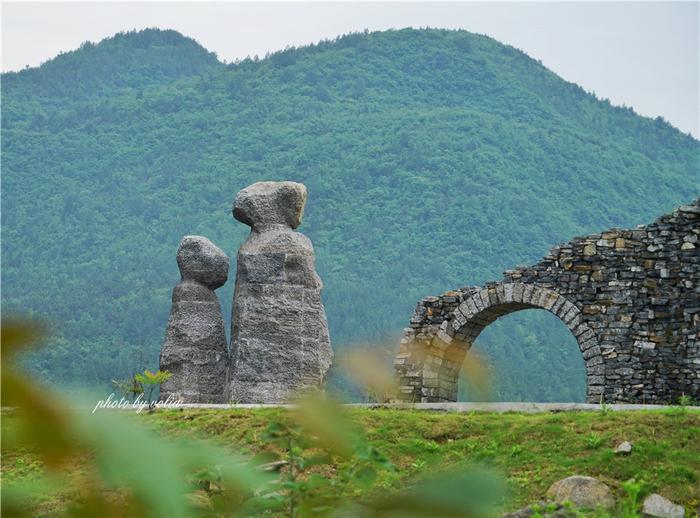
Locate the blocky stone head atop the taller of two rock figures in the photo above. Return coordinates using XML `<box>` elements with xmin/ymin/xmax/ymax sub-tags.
<box><xmin>233</xmin><ymin>182</ymin><xmax>306</xmax><ymax>230</ymax></box>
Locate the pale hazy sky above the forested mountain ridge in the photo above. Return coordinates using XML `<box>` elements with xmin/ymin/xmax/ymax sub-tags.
<box><xmin>2</xmin><ymin>1</ymin><xmax>700</xmax><ymax>137</ymax></box>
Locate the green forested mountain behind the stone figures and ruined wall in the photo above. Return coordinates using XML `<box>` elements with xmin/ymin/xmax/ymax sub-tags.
<box><xmin>2</xmin><ymin>30</ymin><xmax>700</xmax><ymax>400</ymax></box>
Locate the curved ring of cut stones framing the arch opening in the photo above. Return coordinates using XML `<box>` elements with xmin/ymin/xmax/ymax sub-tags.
<box><xmin>432</xmin><ymin>282</ymin><xmax>604</xmax><ymax>402</ymax></box>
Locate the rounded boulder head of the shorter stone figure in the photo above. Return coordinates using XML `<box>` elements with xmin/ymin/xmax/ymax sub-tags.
<box><xmin>177</xmin><ymin>236</ymin><xmax>228</xmax><ymax>290</ymax></box>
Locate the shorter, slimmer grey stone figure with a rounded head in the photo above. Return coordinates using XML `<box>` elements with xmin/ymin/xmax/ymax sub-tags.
<box><xmin>160</xmin><ymin>236</ymin><xmax>229</xmax><ymax>403</ymax></box>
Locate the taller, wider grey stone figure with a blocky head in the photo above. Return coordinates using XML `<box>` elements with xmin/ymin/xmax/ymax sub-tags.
<box><xmin>230</xmin><ymin>182</ymin><xmax>333</xmax><ymax>403</ymax></box>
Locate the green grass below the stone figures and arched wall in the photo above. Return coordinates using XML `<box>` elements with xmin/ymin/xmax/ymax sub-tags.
<box><xmin>2</xmin><ymin>408</ymin><xmax>700</xmax><ymax>516</ymax></box>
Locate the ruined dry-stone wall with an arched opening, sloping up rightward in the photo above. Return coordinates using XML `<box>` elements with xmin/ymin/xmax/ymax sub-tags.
<box><xmin>394</xmin><ymin>200</ymin><xmax>700</xmax><ymax>403</ymax></box>
